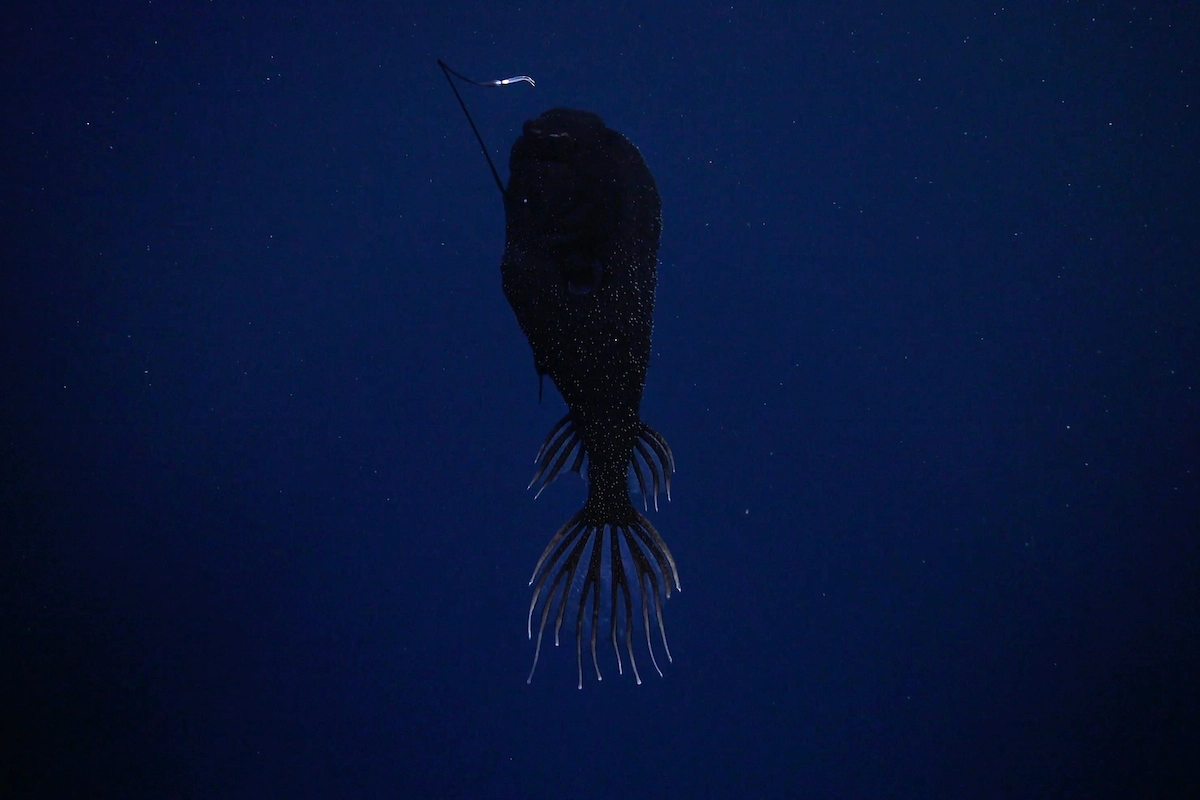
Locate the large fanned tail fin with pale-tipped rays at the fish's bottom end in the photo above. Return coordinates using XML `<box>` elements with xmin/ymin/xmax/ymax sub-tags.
<box><xmin>526</xmin><ymin>505</ymin><xmax>679</xmax><ymax>688</ymax></box>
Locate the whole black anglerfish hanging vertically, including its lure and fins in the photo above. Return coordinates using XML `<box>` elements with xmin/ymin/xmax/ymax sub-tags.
<box><xmin>438</xmin><ymin>61</ymin><xmax>679</xmax><ymax>688</ymax></box>
